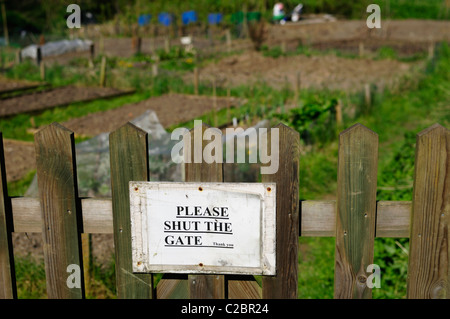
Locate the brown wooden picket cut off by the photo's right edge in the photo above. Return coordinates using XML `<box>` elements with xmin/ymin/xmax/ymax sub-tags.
<box><xmin>407</xmin><ymin>124</ymin><xmax>450</xmax><ymax>299</ymax></box>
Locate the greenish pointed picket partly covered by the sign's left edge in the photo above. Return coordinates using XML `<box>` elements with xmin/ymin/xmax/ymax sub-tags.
<box><xmin>109</xmin><ymin>123</ymin><xmax>153</xmax><ymax>299</ymax></box>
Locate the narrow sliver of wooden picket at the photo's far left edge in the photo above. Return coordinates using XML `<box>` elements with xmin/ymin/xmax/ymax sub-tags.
<box><xmin>0</xmin><ymin>133</ymin><xmax>17</xmax><ymax>299</ymax></box>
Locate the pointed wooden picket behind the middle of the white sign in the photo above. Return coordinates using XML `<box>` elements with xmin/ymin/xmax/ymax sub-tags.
<box><xmin>185</xmin><ymin>124</ymin><xmax>225</xmax><ymax>299</ymax></box>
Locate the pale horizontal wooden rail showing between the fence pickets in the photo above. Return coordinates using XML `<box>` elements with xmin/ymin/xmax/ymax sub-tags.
<box><xmin>11</xmin><ymin>197</ymin><xmax>411</xmax><ymax>238</ymax></box>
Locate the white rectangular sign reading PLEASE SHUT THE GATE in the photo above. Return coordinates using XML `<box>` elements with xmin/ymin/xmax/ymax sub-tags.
<box><xmin>130</xmin><ymin>182</ymin><xmax>276</xmax><ymax>275</ymax></box>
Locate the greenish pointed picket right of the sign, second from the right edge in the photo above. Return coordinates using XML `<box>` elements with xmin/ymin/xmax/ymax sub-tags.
<box><xmin>334</xmin><ymin>124</ymin><xmax>378</xmax><ymax>299</ymax></box>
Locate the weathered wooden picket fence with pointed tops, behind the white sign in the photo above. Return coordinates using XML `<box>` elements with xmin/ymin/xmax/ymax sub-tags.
<box><xmin>0</xmin><ymin>123</ymin><xmax>450</xmax><ymax>299</ymax></box>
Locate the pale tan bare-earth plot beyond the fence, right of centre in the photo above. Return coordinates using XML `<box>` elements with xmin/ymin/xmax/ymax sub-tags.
<box><xmin>195</xmin><ymin>52</ymin><xmax>417</xmax><ymax>91</ymax></box>
